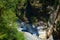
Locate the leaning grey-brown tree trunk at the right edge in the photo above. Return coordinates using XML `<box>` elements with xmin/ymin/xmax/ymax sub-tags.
<box><xmin>48</xmin><ymin>1</ymin><xmax>60</xmax><ymax>38</ymax></box>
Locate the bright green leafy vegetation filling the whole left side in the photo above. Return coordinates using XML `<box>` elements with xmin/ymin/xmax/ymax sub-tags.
<box><xmin>0</xmin><ymin>0</ymin><xmax>25</xmax><ymax>40</ymax></box>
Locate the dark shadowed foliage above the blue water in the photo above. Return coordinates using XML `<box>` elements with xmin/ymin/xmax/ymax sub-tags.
<box><xmin>16</xmin><ymin>0</ymin><xmax>59</xmax><ymax>23</ymax></box>
